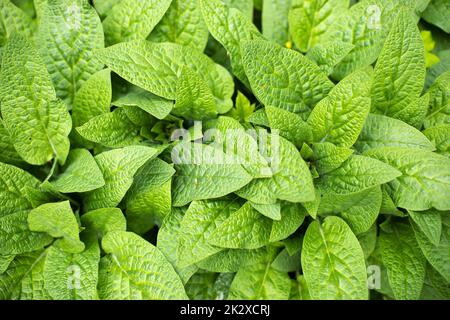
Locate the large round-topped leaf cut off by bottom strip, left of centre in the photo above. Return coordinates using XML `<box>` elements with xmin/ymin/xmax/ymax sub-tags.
<box><xmin>98</xmin><ymin>231</ymin><xmax>187</xmax><ymax>300</ymax></box>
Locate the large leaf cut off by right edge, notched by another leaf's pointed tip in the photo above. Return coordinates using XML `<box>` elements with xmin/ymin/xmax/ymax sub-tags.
<box><xmin>366</xmin><ymin>147</ymin><xmax>450</xmax><ymax>211</ymax></box>
